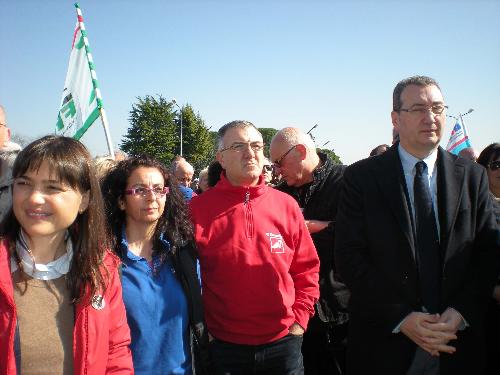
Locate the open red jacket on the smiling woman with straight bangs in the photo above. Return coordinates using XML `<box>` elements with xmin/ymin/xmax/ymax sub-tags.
<box><xmin>0</xmin><ymin>241</ymin><xmax>134</xmax><ymax>375</ymax></box>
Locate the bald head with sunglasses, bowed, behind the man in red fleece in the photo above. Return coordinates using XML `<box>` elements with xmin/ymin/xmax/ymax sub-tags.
<box><xmin>270</xmin><ymin>127</ymin><xmax>320</xmax><ymax>186</ymax></box>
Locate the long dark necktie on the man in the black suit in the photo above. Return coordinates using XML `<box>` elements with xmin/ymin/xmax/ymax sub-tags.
<box><xmin>413</xmin><ymin>161</ymin><xmax>441</xmax><ymax>314</ymax></box>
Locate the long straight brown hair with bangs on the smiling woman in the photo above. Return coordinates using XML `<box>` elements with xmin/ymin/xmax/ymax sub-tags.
<box><xmin>2</xmin><ymin>135</ymin><xmax>109</xmax><ymax>302</ymax></box>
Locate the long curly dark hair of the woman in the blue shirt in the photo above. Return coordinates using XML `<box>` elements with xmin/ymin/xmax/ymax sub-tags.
<box><xmin>102</xmin><ymin>155</ymin><xmax>194</xmax><ymax>261</ymax></box>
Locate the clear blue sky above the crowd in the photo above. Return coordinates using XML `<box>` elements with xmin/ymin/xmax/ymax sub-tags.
<box><xmin>0</xmin><ymin>0</ymin><xmax>500</xmax><ymax>164</ymax></box>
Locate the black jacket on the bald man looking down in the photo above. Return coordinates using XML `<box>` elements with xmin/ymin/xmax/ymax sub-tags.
<box><xmin>276</xmin><ymin>153</ymin><xmax>349</xmax><ymax>324</ymax></box>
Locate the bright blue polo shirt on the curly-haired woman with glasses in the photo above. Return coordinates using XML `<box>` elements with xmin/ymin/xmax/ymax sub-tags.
<box><xmin>121</xmin><ymin>231</ymin><xmax>192</xmax><ymax>375</ymax></box>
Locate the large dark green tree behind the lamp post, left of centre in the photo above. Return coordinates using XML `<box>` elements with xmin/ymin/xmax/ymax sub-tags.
<box><xmin>120</xmin><ymin>95</ymin><xmax>215</xmax><ymax>169</ymax></box>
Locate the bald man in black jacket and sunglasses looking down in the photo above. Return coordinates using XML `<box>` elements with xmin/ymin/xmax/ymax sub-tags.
<box><xmin>270</xmin><ymin>127</ymin><xmax>349</xmax><ymax>375</ymax></box>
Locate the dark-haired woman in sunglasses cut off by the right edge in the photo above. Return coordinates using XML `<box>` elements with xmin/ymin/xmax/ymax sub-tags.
<box><xmin>477</xmin><ymin>143</ymin><xmax>500</xmax><ymax>374</ymax></box>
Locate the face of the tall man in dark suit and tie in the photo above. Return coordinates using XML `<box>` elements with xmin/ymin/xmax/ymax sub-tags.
<box><xmin>391</xmin><ymin>85</ymin><xmax>446</xmax><ymax>158</ymax></box>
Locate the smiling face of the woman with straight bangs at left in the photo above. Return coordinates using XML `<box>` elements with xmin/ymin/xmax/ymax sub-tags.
<box><xmin>12</xmin><ymin>162</ymin><xmax>89</xmax><ymax>245</ymax></box>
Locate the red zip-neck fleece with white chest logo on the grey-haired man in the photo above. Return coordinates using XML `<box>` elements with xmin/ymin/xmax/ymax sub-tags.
<box><xmin>190</xmin><ymin>176</ymin><xmax>319</xmax><ymax>345</ymax></box>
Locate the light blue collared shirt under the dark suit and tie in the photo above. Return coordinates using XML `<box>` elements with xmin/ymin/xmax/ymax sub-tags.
<box><xmin>398</xmin><ymin>143</ymin><xmax>439</xmax><ymax>236</ymax></box>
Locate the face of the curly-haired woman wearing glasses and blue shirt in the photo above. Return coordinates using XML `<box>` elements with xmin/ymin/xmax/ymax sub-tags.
<box><xmin>119</xmin><ymin>167</ymin><xmax>166</xmax><ymax>227</ymax></box>
